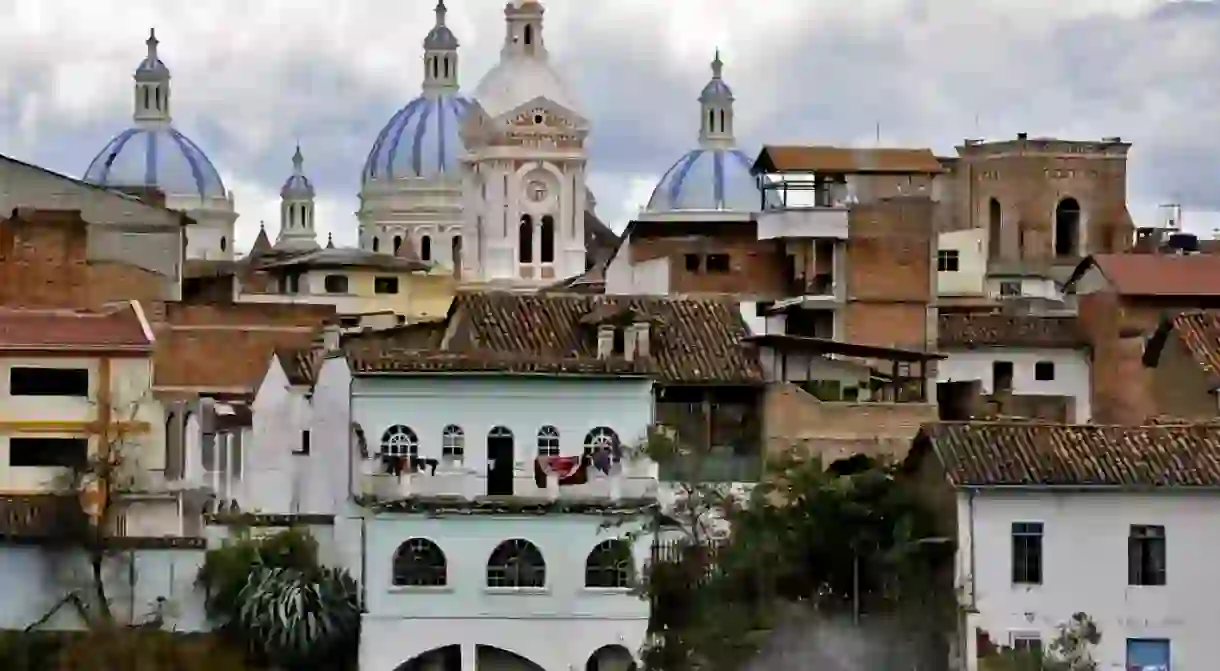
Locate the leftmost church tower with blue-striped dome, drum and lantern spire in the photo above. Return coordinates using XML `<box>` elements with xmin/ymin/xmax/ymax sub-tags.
<box><xmin>83</xmin><ymin>31</ymin><xmax>237</xmax><ymax>259</ymax></box>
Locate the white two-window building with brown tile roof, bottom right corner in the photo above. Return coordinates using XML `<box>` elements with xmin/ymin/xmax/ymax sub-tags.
<box><xmin>913</xmin><ymin>423</ymin><xmax>1220</xmax><ymax>671</ymax></box>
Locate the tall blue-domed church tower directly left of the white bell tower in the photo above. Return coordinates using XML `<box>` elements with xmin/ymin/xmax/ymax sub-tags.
<box><xmin>356</xmin><ymin>0</ymin><xmax>471</xmax><ymax>268</ymax></box>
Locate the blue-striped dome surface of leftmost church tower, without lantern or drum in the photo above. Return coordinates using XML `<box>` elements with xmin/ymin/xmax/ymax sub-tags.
<box><xmin>83</xmin><ymin>126</ymin><xmax>226</xmax><ymax>198</ymax></box>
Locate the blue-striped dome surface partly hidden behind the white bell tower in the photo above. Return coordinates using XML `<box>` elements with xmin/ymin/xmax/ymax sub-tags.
<box><xmin>362</xmin><ymin>93</ymin><xmax>473</xmax><ymax>181</ymax></box>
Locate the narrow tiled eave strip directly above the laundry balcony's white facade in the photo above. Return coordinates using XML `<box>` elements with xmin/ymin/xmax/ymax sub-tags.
<box><xmin>348</xmin><ymin>350</ymin><xmax>649</xmax><ymax>377</ymax></box>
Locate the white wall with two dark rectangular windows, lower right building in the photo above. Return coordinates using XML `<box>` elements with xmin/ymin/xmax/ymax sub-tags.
<box><xmin>958</xmin><ymin>490</ymin><xmax>1220</xmax><ymax>671</ymax></box>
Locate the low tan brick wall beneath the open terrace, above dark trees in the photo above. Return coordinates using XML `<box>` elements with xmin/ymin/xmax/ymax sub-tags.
<box><xmin>763</xmin><ymin>383</ymin><xmax>937</xmax><ymax>464</ymax></box>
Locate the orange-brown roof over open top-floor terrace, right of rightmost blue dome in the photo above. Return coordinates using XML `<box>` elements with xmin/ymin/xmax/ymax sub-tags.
<box><xmin>754</xmin><ymin>145</ymin><xmax>944</xmax><ymax>173</ymax></box>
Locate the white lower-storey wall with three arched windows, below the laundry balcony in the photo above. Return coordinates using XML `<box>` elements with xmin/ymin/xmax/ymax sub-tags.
<box><xmin>360</xmin><ymin>514</ymin><xmax>651</xmax><ymax>671</ymax></box>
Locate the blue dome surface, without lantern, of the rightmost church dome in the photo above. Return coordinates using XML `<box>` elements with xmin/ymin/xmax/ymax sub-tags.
<box><xmin>648</xmin><ymin>149</ymin><xmax>763</xmax><ymax>212</ymax></box>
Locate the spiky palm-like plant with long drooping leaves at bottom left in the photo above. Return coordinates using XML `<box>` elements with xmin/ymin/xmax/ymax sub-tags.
<box><xmin>237</xmin><ymin>565</ymin><xmax>360</xmax><ymax>664</ymax></box>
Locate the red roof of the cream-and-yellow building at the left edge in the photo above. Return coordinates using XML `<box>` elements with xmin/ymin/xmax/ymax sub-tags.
<box><xmin>0</xmin><ymin>303</ymin><xmax>153</xmax><ymax>353</ymax></box>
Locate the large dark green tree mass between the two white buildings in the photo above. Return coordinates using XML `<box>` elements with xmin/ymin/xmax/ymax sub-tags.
<box><xmin>642</xmin><ymin>434</ymin><xmax>956</xmax><ymax>671</ymax></box>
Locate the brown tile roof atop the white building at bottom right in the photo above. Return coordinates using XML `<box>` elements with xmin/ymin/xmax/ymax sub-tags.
<box><xmin>915</xmin><ymin>422</ymin><xmax>1220</xmax><ymax>488</ymax></box>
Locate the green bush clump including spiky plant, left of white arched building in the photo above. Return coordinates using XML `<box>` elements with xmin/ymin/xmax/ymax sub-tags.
<box><xmin>196</xmin><ymin>529</ymin><xmax>360</xmax><ymax>669</ymax></box>
